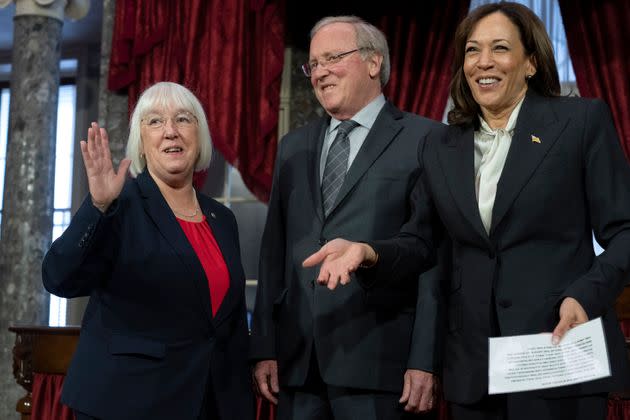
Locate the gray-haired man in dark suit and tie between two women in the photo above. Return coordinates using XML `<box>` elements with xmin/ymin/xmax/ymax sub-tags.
<box><xmin>251</xmin><ymin>16</ymin><xmax>445</xmax><ymax>420</ymax></box>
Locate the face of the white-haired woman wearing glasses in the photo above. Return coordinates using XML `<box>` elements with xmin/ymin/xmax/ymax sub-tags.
<box><xmin>141</xmin><ymin>109</ymin><xmax>199</xmax><ymax>185</ymax></box>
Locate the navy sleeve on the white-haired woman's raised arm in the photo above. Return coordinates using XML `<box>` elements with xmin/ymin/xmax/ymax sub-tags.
<box><xmin>42</xmin><ymin>196</ymin><xmax>119</xmax><ymax>298</ymax></box>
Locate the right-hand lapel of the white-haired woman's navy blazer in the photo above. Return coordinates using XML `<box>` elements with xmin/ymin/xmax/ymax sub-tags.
<box><xmin>197</xmin><ymin>194</ymin><xmax>245</xmax><ymax>326</ymax></box>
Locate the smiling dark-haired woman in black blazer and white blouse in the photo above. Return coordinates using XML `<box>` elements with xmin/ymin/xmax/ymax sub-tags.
<box><xmin>306</xmin><ymin>2</ymin><xmax>630</xmax><ymax>420</ymax></box>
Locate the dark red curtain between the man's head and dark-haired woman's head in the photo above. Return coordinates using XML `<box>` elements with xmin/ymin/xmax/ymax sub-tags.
<box><xmin>379</xmin><ymin>0</ymin><xmax>470</xmax><ymax>121</ymax></box>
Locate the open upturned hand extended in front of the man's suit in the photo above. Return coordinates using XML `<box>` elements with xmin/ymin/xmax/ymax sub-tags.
<box><xmin>302</xmin><ymin>238</ymin><xmax>376</xmax><ymax>290</ymax></box>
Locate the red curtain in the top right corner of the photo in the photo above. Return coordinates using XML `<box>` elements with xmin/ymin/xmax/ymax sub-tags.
<box><xmin>559</xmin><ymin>0</ymin><xmax>630</xmax><ymax>159</ymax></box>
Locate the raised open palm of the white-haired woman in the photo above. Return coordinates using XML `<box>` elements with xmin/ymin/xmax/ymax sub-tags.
<box><xmin>81</xmin><ymin>123</ymin><xmax>131</xmax><ymax>212</ymax></box>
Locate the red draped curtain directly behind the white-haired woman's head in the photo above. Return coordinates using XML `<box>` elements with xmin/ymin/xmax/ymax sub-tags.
<box><xmin>108</xmin><ymin>0</ymin><xmax>285</xmax><ymax>201</ymax></box>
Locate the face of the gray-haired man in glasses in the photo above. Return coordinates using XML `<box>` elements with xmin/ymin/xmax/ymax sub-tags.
<box><xmin>309</xmin><ymin>22</ymin><xmax>383</xmax><ymax>120</ymax></box>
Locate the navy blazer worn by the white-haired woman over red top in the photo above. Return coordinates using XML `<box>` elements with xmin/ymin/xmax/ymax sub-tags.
<box><xmin>43</xmin><ymin>171</ymin><xmax>253</xmax><ymax>420</ymax></box>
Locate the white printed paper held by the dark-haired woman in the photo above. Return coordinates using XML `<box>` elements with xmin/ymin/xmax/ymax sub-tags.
<box><xmin>488</xmin><ymin>318</ymin><xmax>610</xmax><ymax>394</ymax></box>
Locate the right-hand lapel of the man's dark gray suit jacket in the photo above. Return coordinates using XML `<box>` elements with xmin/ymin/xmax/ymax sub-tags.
<box><xmin>328</xmin><ymin>102</ymin><xmax>402</xmax><ymax>217</ymax></box>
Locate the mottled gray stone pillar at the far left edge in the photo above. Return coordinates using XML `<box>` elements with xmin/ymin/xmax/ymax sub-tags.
<box><xmin>0</xmin><ymin>0</ymin><xmax>89</xmax><ymax>419</ymax></box>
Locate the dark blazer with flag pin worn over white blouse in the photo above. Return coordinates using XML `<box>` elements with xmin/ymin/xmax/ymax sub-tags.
<box><xmin>374</xmin><ymin>92</ymin><xmax>630</xmax><ymax>403</ymax></box>
